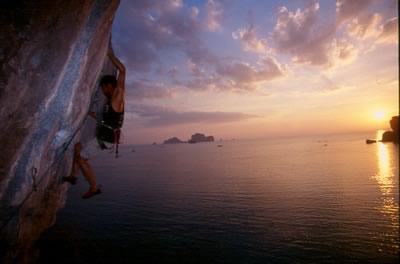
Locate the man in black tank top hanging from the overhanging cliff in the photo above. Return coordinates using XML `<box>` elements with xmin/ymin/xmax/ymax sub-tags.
<box><xmin>64</xmin><ymin>45</ymin><xmax>125</xmax><ymax>199</ymax></box>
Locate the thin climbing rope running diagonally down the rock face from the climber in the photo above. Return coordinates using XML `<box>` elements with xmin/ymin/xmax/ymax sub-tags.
<box><xmin>0</xmin><ymin>82</ymin><xmax>99</xmax><ymax>232</ymax></box>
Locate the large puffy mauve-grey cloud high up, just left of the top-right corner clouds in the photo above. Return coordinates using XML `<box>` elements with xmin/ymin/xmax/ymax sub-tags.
<box><xmin>271</xmin><ymin>2</ymin><xmax>335</xmax><ymax>65</ymax></box>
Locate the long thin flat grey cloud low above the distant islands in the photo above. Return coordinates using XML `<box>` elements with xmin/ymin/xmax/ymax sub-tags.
<box><xmin>127</xmin><ymin>104</ymin><xmax>259</xmax><ymax>127</ymax></box>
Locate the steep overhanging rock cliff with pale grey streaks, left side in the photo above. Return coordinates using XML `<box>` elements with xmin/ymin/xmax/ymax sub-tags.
<box><xmin>0</xmin><ymin>0</ymin><xmax>119</xmax><ymax>263</ymax></box>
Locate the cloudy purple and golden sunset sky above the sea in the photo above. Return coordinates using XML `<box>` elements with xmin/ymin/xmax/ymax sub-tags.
<box><xmin>112</xmin><ymin>0</ymin><xmax>399</xmax><ymax>144</ymax></box>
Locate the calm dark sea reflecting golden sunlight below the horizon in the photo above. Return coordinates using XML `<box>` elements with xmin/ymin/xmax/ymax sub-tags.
<box><xmin>38</xmin><ymin>132</ymin><xmax>399</xmax><ymax>264</ymax></box>
